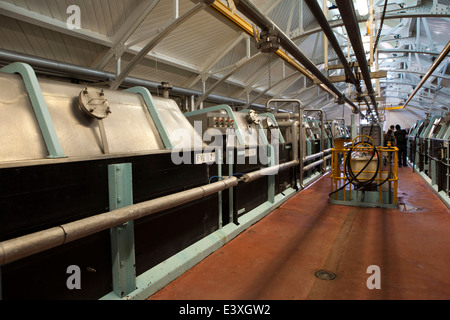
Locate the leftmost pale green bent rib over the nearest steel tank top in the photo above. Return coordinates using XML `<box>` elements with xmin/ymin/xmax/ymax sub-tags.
<box><xmin>0</xmin><ymin>62</ymin><xmax>66</xmax><ymax>158</ymax></box>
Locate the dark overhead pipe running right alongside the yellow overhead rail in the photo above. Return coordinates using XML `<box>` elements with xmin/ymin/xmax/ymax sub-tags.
<box><xmin>230</xmin><ymin>0</ymin><xmax>359</xmax><ymax>112</ymax></box>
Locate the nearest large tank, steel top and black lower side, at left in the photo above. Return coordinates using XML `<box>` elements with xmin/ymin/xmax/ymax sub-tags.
<box><xmin>0</xmin><ymin>65</ymin><xmax>219</xmax><ymax>300</ymax></box>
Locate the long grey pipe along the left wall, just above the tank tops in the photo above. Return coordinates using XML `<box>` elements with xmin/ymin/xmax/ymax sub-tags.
<box><xmin>0</xmin><ymin>49</ymin><xmax>265</xmax><ymax>109</ymax></box>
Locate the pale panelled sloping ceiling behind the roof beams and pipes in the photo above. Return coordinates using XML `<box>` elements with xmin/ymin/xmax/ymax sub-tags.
<box><xmin>0</xmin><ymin>0</ymin><xmax>450</xmax><ymax>119</ymax></box>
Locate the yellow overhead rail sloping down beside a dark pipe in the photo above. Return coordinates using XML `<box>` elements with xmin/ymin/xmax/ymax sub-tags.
<box><xmin>211</xmin><ymin>0</ymin><xmax>336</xmax><ymax>97</ymax></box>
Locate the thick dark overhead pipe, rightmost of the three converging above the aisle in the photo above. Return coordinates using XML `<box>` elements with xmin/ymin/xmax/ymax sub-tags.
<box><xmin>336</xmin><ymin>0</ymin><xmax>379</xmax><ymax>119</ymax></box>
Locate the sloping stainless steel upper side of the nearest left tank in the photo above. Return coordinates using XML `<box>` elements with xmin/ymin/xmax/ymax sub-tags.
<box><xmin>0</xmin><ymin>73</ymin><xmax>201</xmax><ymax>165</ymax></box>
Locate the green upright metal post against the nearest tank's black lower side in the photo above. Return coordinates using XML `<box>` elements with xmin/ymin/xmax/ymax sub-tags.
<box><xmin>108</xmin><ymin>163</ymin><xmax>136</xmax><ymax>298</ymax></box>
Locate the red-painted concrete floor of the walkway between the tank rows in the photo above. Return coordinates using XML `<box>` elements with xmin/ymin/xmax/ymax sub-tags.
<box><xmin>149</xmin><ymin>168</ymin><xmax>450</xmax><ymax>300</ymax></box>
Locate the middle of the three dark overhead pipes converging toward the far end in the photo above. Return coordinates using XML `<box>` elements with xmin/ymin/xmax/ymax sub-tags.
<box><xmin>305</xmin><ymin>0</ymin><xmax>371</xmax><ymax>115</ymax></box>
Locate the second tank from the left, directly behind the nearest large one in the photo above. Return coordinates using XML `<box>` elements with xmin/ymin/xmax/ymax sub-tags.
<box><xmin>185</xmin><ymin>105</ymin><xmax>296</xmax><ymax>225</ymax></box>
